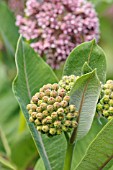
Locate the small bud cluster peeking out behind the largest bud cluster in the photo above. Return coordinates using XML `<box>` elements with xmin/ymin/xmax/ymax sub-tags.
<box><xmin>59</xmin><ymin>75</ymin><xmax>79</xmax><ymax>94</ymax></box>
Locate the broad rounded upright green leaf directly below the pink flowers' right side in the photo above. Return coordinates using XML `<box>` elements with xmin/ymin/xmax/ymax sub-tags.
<box><xmin>63</xmin><ymin>40</ymin><xmax>106</xmax><ymax>82</ymax></box>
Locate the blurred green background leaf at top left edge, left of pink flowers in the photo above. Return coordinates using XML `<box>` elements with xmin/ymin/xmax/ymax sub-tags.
<box><xmin>0</xmin><ymin>1</ymin><xmax>19</xmax><ymax>56</ymax></box>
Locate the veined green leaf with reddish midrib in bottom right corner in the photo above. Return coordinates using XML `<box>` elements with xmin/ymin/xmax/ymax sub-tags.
<box><xmin>75</xmin><ymin>120</ymin><xmax>113</xmax><ymax>170</ymax></box>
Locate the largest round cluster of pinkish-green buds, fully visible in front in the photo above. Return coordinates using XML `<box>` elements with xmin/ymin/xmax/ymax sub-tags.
<box><xmin>27</xmin><ymin>83</ymin><xmax>78</xmax><ymax>136</ymax></box>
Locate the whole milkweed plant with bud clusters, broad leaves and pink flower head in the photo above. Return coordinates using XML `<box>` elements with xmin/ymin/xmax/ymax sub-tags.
<box><xmin>13</xmin><ymin>0</ymin><xmax>113</xmax><ymax>170</ymax></box>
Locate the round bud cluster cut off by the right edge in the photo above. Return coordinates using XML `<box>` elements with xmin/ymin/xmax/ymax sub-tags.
<box><xmin>96</xmin><ymin>80</ymin><xmax>113</xmax><ymax>120</ymax></box>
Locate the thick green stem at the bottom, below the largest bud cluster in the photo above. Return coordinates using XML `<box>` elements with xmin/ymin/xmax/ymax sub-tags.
<box><xmin>64</xmin><ymin>142</ymin><xmax>75</xmax><ymax>170</ymax></box>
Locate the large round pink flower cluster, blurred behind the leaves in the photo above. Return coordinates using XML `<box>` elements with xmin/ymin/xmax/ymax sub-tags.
<box><xmin>16</xmin><ymin>0</ymin><xmax>99</xmax><ymax>69</ymax></box>
